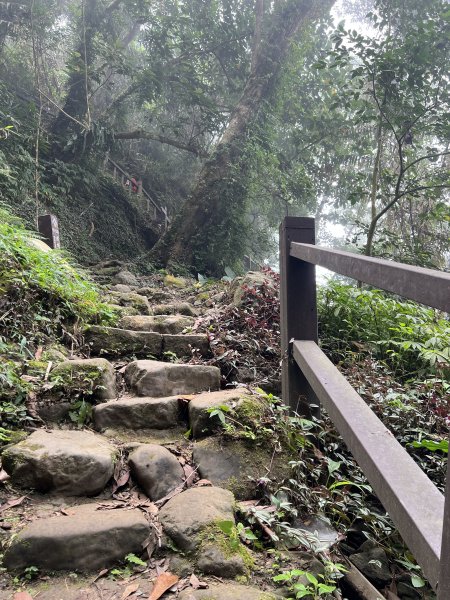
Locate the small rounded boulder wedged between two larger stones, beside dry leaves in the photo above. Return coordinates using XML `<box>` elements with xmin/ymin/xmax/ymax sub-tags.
<box><xmin>128</xmin><ymin>444</ymin><xmax>184</xmax><ymax>501</ymax></box>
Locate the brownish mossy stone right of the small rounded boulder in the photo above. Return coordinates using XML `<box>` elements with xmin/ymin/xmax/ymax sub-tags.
<box><xmin>193</xmin><ymin>437</ymin><xmax>292</xmax><ymax>500</ymax></box>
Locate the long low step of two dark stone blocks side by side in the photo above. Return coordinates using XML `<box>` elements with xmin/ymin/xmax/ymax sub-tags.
<box><xmin>84</xmin><ymin>325</ymin><xmax>210</xmax><ymax>358</ymax></box>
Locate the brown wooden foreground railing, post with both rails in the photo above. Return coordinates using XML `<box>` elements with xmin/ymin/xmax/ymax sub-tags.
<box><xmin>280</xmin><ymin>217</ymin><xmax>450</xmax><ymax>600</ymax></box>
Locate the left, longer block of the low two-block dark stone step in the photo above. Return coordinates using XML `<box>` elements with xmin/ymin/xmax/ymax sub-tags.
<box><xmin>84</xmin><ymin>325</ymin><xmax>163</xmax><ymax>357</ymax></box>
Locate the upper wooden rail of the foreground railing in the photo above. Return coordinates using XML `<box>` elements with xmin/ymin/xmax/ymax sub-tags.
<box><xmin>290</xmin><ymin>240</ymin><xmax>450</xmax><ymax>314</ymax></box>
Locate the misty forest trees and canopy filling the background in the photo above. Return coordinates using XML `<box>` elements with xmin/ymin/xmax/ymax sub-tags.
<box><xmin>0</xmin><ymin>0</ymin><xmax>450</xmax><ymax>275</ymax></box>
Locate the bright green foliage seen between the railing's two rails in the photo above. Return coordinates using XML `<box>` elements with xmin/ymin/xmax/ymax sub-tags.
<box><xmin>318</xmin><ymin>281</ymin><xmax>450</xmax><ymax>379</ymax></box>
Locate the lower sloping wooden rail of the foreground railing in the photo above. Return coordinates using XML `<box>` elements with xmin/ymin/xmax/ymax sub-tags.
<box><xmin>293</xmin><ymin>341</ymin><xmax>442</xmax><ymax>588</ymax></box>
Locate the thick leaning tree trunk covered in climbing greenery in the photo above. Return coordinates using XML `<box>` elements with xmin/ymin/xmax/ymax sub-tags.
<box><xmin>150</xmin><ymin>0</ymin><xmax>335</xmax><ymax>276</ymax></box>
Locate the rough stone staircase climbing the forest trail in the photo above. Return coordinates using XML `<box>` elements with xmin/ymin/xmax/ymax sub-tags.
<box><xmin>0</xmin><ymin>276</ymin><xmax>287</xmax><ymax>600</ymax></box>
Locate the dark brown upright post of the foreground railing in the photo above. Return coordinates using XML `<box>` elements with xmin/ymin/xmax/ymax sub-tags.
<box><xmin>280</xmin><ymin>217</ymin><xmax>319</xmax><ymax>416</ymax></box>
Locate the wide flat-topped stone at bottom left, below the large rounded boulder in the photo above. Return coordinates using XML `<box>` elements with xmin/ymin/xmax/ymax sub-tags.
<box><xmin>4</xmin><ymin>504</ymin><xmax>150</xmax><ymax>571</ymax></box>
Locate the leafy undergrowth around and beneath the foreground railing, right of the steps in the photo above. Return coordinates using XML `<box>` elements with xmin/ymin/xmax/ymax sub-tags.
<box><xmin>201</xmin><ymin>274</ymin><xmax>450</xmax><ymax>598</ymax></box>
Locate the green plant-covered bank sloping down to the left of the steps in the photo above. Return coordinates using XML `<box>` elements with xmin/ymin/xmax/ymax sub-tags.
<box><xmin>0</xmin><ymin>206</ymin><xmax>114</xmax><ymax>441</ymax></box>
